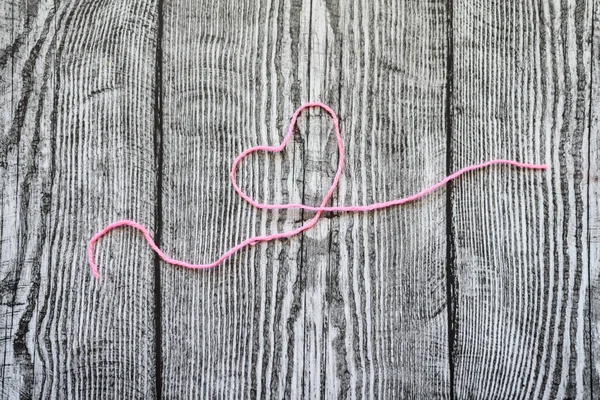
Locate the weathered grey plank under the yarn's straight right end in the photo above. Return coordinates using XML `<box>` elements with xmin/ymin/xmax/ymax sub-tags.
<box><xmin>452</xmin><ymin>1</ymin><xmax>592</xmax><ymax>398</ymax></box>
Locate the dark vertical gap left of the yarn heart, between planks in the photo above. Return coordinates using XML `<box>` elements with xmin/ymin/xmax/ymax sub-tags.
<box><xmin>154</xmin><ymin>0</ymin><xmax>164</xmax><ymax>399</ymax></box>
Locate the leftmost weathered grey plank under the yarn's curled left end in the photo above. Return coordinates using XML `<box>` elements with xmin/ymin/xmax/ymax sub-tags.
<box><xmin>0</xmin><ymin>0</ymin><xmax>156</xmax><ymax>398</ymax></box>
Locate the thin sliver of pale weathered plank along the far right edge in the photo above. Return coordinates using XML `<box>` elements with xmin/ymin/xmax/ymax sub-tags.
<box><xmin>587</xmin><ymin>1</ymin><xmax>600</xmax><ymax>398</ymax></box>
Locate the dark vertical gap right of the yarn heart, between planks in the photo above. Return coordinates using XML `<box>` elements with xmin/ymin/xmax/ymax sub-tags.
<box><xmin>445</xmin><ymin>0</ymin><xmax>456</xmax><ymax>399</ymax></box>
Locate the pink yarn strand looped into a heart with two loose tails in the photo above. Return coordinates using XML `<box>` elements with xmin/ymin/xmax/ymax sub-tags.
<box><xmin>87</xmin><ymin>102</ymin><xmax>547</xmax><ymax>278</ymax></box>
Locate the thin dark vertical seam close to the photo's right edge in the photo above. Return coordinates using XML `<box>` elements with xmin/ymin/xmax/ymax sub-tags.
<box><xmin>586</xmin><ymin>1</ymin><xmax>596</xmax><ymax>399</ymax></box>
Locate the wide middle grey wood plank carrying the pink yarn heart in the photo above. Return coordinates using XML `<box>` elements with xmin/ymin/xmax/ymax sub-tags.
<box><xmin>160</xmin><ymin>0</ymin><xmax>449</xmax><ymax>398</ymax></box>
